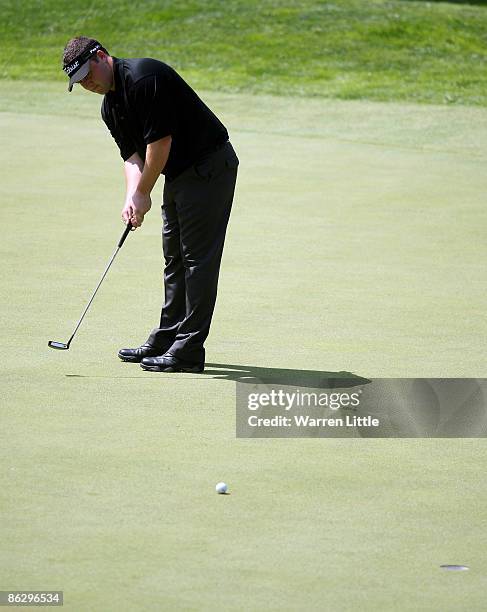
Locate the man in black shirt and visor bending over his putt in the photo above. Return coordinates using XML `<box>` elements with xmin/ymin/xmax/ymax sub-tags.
<box><xmin>63</xmin><ymin>36</ymin><xmax>239</xmax><ymax>372</ymax></box>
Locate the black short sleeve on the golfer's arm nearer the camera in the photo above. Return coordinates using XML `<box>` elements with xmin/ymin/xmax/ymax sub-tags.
<box><xmin>134</xmin><ymin>74</ymin><xmax>176</xmax><ymax>145</ymax></box>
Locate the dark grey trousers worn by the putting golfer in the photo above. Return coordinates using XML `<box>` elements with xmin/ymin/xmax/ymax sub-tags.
<box><xmin>147</xmin><ymin>142</ymin><xmax>239</xmax><ymax>363</ymax></box>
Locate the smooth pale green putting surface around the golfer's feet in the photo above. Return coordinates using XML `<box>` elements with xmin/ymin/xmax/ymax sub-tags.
<box><xmin>0</xmin><ymin>81</ymin><xmax>487</xmax><ymax>611</ymax></box>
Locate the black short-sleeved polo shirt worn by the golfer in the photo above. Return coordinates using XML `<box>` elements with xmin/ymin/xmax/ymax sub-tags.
<box><xmin>101</xmin><ymin>57</ymin><xmax>228</xmax><ymax>180</ymax></box>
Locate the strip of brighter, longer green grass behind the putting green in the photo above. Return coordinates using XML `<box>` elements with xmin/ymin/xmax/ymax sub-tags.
<box><xmin>0</xmin><ymin>0</ymin><xmax>487</xmax><ymax>105</ymax></box>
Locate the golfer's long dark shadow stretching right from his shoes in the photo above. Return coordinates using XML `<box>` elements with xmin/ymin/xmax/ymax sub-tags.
<box><xmin>203</xmin><ymin>363</ymin><xmax>371</xmax><ymax>389</ymax></box>
